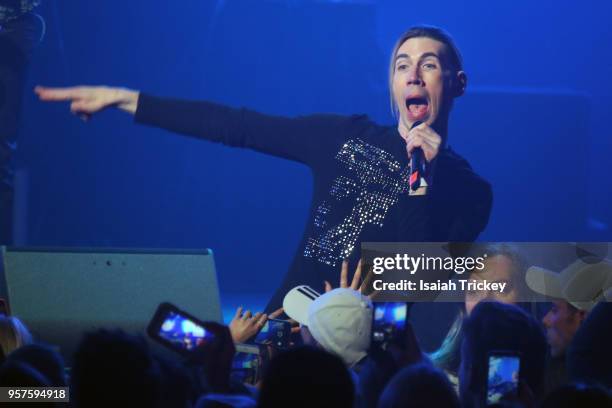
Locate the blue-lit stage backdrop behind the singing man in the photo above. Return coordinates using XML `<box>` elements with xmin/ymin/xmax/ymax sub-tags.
<box><xmin>13</xmin><ymin>0</ymin><xmax>612</xmax><ymax>348</ymax></box>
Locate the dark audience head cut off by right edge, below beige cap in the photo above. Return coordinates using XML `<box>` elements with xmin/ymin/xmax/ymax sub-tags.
<box><xmin>567</xmin><ymin>302</ymin><xmax>612</xmax><ymax>388</ymax></box>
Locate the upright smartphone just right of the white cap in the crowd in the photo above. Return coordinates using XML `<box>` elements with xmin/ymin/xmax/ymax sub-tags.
<box><xmin>371</xmin><ymin>302</ymin><xmax>408</xmax><ymax>348</ymax></box>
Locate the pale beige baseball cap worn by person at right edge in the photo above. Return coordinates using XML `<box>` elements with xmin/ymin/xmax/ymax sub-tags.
<box><xmin>525</xmin><ymin>259</ymin><xmax>612</xmax><ymax>311</ymax></box>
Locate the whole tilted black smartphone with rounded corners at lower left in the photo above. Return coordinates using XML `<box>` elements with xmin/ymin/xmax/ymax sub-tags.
<box><xmin>147</xmin><ymin>303</ymin><xmax>224</xmax><ymax>354</ymax></box>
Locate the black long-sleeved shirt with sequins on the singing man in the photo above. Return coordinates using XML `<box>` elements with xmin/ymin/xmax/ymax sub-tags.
<box><xmin>135</xmin><ymin>94</ymin><xmax>492</xmax><ymax>311</ymax></box>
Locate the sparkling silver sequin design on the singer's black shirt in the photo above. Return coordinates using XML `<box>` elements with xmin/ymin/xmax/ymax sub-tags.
<box><xmin>304</xmin><ymin>139</ymin><xmax>409</xmax><ymax>266</ymax></box>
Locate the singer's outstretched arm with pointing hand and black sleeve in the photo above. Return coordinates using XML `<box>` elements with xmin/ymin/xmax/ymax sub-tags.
<box><xmin>35</xmin><ymin>86</ymin><xmax>369</xmax><ymax>166</ymax></box>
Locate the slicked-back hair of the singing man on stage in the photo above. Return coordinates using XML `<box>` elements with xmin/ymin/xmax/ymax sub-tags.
<box><xmin>389</xmin><ymin>24</ymin><xmax>463</xmax><ymax>112</ymax></box>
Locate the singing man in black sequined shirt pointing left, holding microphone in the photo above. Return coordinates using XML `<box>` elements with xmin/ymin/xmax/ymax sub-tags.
<box><xmin>35</xmin><ymin>26</ymin><xmax>492</xmax><ymax>310</ymax></box>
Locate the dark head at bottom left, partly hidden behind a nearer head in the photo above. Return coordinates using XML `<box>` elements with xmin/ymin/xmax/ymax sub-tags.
<box><xmin>7</xmin><ymin>344</ymin><xmax>66</xmax><ymax>387</ymax></box>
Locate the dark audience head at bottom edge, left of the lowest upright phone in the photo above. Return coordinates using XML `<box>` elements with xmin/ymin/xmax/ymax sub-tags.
<box><xmin>378</xmin><ymin>363</ymin><xmax>459</xmax><ymax>408</ymax></box>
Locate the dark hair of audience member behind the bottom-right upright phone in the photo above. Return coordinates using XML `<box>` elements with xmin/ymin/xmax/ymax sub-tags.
<box><xmin>459</xmin><ymin>301</ymin><xmax>548</xmax><ymax>406</ymax></box>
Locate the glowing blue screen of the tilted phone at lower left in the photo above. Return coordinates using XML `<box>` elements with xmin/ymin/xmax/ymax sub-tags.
<box><xmin>158</xmin><ymin>311</ymin><xmax>214</xmax><ymax>351</ymax></box>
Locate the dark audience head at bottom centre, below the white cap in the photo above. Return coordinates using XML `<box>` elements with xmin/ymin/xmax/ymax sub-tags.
<box><xmin>259</xmin><ymin>346</ymin><xmax>355</xmax><ymax>408</ymax></box>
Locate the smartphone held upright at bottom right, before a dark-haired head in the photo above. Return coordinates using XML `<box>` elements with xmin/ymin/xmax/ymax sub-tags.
<box><xmin>486</xmin><ymin>351</ymin><xmax>521</xmax><ymax>405</ymax></box>
